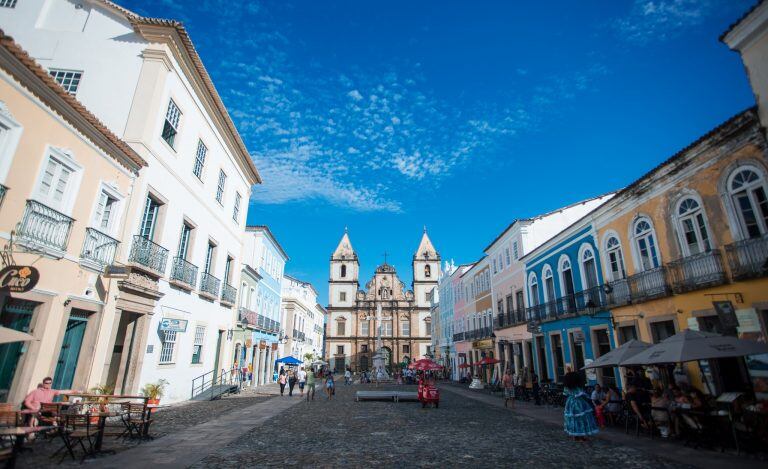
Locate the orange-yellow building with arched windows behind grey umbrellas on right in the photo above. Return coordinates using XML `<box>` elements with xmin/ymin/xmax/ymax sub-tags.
<box><xmin>593</xmin><ymin>109</ymin><xmax>768</xmax><ymax>392</ymax></box>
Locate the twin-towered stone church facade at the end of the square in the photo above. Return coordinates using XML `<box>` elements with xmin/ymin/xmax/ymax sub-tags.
<box><xmin>324</xmin><ymin>230</ymin><xmax>440</xmax><ymax>372</ymax></box>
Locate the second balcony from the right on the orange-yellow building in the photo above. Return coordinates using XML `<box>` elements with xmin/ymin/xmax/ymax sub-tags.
<box><xmin>667</xmin><ymin>250</ymin><xmax>728</xmax><ymax>293</ymax></box>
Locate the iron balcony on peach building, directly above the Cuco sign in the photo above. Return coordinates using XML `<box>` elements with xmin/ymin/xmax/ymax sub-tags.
<box><xmin>17</xmin><ymin>200</ymin><xmax>74</xmax><ymax>257</ymax></box>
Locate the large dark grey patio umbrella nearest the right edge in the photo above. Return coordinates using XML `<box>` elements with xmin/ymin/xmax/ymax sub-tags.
<box><xmin>622</xmin><ymin>329</ymin><xmax>768</xmax><ymax>366</ymax></box>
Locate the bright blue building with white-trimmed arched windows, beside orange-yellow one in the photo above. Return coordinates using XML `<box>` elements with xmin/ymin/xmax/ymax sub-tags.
<box><xmin>522</xmin><ymin>223</ymin><xmax>618</xmax><ymax>385</ymax></box>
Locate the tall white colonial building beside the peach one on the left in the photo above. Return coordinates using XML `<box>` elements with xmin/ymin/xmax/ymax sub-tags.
<box><xmin>0</xmin><ymin>0</ymin><xmax>260</xmax><ymax>402</ymax></box>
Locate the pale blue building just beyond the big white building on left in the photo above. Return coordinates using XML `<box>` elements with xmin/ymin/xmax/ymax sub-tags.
<box><xmin>233</xmin><ymin>225</ymin><xmax>288</xmax><ymax>385</ymax></box>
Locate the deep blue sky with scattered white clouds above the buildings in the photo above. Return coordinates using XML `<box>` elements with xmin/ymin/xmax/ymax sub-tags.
<box><xmin>121</xmin><ymin>0</ymin><xmax>754</xmax><ymax>304</ymax></box>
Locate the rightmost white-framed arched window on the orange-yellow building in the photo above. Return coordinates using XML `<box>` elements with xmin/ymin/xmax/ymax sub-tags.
<box><xmin>728</xmin><ymin>166</ymin><xmax>768</xmax><ymax>238</ymax></box>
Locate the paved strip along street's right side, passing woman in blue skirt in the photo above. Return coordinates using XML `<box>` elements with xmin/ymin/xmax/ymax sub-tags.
<box><xmin>439</xmin><ymin>381</ymin><xmax>766</xmax><ymax>469</ymax></box>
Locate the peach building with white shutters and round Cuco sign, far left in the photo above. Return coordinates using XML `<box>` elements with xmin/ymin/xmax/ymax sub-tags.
<box><xmin>0</xmin><ymin>32</ymin><xmax>146</xmax><ymax>403</ymax></box>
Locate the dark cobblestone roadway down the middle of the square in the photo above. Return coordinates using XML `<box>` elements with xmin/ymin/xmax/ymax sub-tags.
<box><xmin>193</xmin><ymin>385</ymin><xmax>684</xmax><ymax>469</ymax></box>
